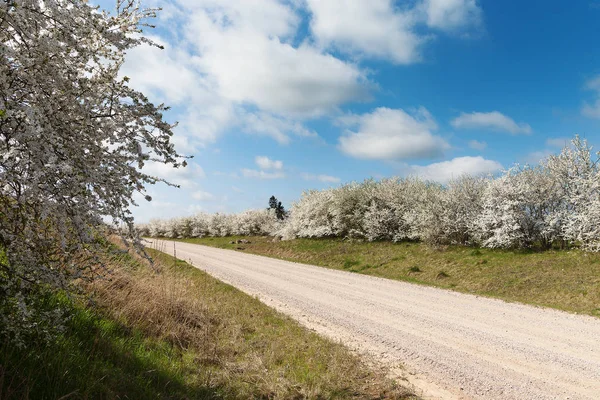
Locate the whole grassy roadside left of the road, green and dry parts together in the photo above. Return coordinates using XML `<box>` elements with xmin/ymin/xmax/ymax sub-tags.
<box><xmin>0</xmin><ymin>245</ymin><xmax>414</xmax><ymax>399</ymax></box>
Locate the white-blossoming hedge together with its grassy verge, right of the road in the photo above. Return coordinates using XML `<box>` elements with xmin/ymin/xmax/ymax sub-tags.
<box><xmin>143</xmin><ymin>136</ymin><xmax>600</xmax><ymax>316</ymax></box>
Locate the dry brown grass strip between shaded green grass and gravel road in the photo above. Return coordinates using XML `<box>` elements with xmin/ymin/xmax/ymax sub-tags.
<box><xmin>91</xmin><ymin>242</ymin><xmax>413</xmax><ymax>399</ymax></box>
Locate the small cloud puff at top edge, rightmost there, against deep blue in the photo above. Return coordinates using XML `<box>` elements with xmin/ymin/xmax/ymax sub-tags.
<box><xmin>423</xmin><ymin>0</ymin><xmax>482</xmax><ymax>31</ymax></box>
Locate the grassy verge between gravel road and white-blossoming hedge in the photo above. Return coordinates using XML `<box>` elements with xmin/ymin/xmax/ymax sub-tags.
<box><xmin>176</xmin><ymin>237</ymin><xmax>600</xmax><ymax>316</ymax></box>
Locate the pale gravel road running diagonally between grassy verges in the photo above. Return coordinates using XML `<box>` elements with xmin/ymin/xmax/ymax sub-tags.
<box><xmin>149</xmin><ymin>241</ymin><xmax>600</xmax><ymax>400</ymax></box>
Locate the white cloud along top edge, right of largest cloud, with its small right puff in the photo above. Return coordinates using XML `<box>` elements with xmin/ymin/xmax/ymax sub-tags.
<box><xmin>306</xmin><ymin>0</ymin><xmax>482</xmax><ymax>64</ymax></box>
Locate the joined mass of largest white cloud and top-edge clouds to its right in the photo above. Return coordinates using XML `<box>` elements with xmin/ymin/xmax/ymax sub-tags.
<box><xmin>123</xmin><ymin>0</ymin><xmax>488</xmax><ymax>151</ymax></box>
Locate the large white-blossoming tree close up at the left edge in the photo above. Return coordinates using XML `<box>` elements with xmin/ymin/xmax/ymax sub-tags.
<box><xmin>0</xmin><ymin>0</ymin><xmax>181</xmax><ymax>344</ymax></box>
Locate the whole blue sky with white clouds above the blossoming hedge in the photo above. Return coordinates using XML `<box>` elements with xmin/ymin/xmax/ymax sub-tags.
<box><xmin>105</xmin><ymin>0</ymin><xmax>600</xmax><ymax>222</ymax></box>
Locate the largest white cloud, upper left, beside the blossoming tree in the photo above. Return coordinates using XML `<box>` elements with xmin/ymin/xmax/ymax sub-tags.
<box><xmin>122</xmin><ymin>0</ymin><xmax>372</xmax><ymax>153</ymax></box>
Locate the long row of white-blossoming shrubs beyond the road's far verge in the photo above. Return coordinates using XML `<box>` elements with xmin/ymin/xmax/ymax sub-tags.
<box><xmin>145</xmin><ymin>137</ymin><xmax>600</xmax><ymax>251</ymax></box>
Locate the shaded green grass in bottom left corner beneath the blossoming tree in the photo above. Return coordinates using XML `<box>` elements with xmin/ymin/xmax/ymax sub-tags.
<box><xmin>0</xmin><ymin>299</ymin><xmax>217</xmax><ymax>399</ymax></box>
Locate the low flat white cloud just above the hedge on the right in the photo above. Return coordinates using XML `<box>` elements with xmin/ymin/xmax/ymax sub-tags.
<box><xmin>409</xmin><ymin>156</ymin><xmax>502</xmax><ymax>183</ymax></box>
